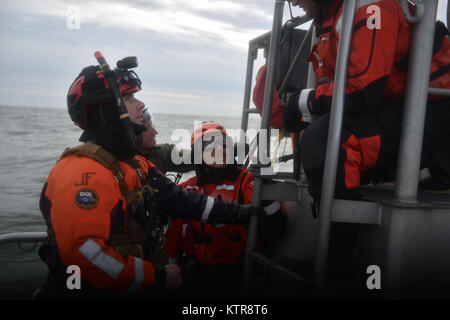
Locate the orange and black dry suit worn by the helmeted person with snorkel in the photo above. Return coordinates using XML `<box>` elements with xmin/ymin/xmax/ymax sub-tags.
<box><xmin>40</xmin><ymin>142</ymin><xmax>250</xmax><ymax>297</ymax></box>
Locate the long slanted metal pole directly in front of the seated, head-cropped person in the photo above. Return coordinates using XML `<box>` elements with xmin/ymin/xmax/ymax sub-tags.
<box><xmin>313</xmin><ymin>0</ymin><xmax>356</xmax><ymax>290</ymax></box>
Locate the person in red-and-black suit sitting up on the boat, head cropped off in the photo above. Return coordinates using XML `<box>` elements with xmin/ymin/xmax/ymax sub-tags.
<box><xmin>284</xmin><ymin>0</ymin><xmax>450</xmax><ymax>280</ymax></box>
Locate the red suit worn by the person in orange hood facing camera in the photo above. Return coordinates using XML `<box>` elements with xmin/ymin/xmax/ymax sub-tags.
<box><xmin>165</xmin><ymin>168</ymin><xmax>281</xmax><ymax>267</ymax></box>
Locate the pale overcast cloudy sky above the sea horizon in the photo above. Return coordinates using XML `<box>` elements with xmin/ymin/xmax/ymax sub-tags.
<box><xmin>0</xmin><ymin>0</ymin><xmax>447</xmax><ymax>116</ymax></box>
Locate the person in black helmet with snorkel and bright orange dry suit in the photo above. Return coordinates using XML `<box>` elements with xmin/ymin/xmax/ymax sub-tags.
<box><xmin>38</xmin><ymin>56</ymin><xmax>264</xmax><ymax>298</ymax></box>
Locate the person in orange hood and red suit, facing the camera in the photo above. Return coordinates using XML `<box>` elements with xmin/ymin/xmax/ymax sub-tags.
<box><xmin>165</xmin><ymin>121</ymin><xmax>285</xmax><ymax>298</ymax></box>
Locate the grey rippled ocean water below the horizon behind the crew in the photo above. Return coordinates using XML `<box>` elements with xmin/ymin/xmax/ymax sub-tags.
<box><xmin>0</xmin><ymin>106</ymin><xmax>292</xmax><ymax>299</ymax></box>
